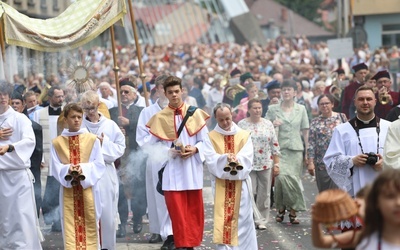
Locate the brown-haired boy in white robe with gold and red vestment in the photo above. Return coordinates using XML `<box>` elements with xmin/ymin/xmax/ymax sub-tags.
<box><xmin>51</xmin><ymin>103</ymin><xmax>105</xmax><ymax>250</ymax></box>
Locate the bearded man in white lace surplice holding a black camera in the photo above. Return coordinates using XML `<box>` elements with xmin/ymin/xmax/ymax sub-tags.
<box><xmin>324</xmin><ymin>86</ymin><xmax>390</xmax><ymax>197</ymax></box>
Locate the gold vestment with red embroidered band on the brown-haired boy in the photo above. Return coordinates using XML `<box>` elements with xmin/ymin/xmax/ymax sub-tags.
<box><xmin>53</xmin><ymin>133</ymin><xmax>98</xmax><ymax>250</ymax></box>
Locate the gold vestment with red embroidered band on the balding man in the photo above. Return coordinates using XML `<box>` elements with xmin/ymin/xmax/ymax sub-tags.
<box><xmin>209</xmin><ymin>130</ymin><xmax>250</xmax><ymax>246</ymax></box>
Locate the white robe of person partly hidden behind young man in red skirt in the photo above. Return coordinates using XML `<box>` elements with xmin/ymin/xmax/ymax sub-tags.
<box><xmin>136</xmin><ymin>102</ymin><xmax>172</xmax><ymax>238</ymax></box>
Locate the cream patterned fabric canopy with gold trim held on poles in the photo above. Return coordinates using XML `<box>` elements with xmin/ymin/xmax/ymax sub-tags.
<box><xmin>0</xmin><ymin>0</ymin><xmax>126</xmax><ymax>52</ymax></box>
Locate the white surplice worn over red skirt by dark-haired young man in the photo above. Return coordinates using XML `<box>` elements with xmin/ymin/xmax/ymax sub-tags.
<box><xmin>149</xmin><ymin>115</ymin><xmax>208</xmax><ymax>191</ymax></box>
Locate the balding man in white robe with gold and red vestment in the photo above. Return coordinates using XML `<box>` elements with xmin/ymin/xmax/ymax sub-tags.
<box><xmin>204</xmin><ymin>103</ymin><xmax>258</xmax><ymax>250</ymax></box>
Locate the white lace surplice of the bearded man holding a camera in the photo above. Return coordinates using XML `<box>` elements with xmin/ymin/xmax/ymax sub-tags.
<box><xmin>324</xmin><ymin>119</ymin><xmax>390</xmax><ymax>197</ymax></box>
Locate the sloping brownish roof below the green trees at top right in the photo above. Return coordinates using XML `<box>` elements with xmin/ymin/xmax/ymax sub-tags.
<box><xmin>246</xmin><ymin>0</ymin><xmax>335</xmax><ymax>37</ymax></box>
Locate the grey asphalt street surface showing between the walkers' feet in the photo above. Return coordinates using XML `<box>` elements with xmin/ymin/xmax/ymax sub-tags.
<box><xmin>41</xmin><ymin>171</ymin><xmax>318</xmax><ymax>250</ymax></box>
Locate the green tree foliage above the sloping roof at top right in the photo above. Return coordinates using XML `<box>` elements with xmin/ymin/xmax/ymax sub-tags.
<box><xmin>275</xmin><ymin>0</ymin><xmax>322</xmax><ymax>21</ymax></box>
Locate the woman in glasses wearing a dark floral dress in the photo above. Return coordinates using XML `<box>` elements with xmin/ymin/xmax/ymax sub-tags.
<box><xmin>307</xmin><ymin>94</ymin><xmax>347</xmax><ymax>192</ymax></box>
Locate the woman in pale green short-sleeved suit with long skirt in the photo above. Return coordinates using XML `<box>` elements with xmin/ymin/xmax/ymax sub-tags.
<box><xmin>266</xmin><ymin>80</ymin><xmax>309</xmax><ymax>224</ymax></box>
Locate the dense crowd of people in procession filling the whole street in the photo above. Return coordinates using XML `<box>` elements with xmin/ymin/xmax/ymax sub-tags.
<box><xmin>0</xmin><ymin>37</ymin><xmax>400</xmax><ymax>250</ymax></box>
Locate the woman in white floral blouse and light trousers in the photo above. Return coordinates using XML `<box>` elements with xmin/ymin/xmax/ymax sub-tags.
<box><xmin>238</xmin><ymin>99</ymin><xmax>279</xmax><ymax>230</ymax></box>
